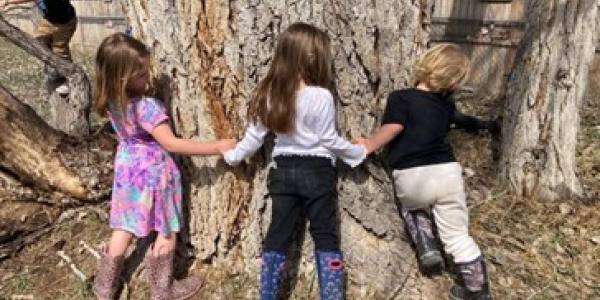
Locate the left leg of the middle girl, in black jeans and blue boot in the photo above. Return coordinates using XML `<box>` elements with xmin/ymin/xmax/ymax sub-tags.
<box><xmin>260</xmin><ymin>168</ymin><xmax>302</xmax><ymax>300</ymax></box>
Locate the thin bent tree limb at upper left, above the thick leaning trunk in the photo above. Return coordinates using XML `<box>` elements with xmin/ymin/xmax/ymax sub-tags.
<box><xmin>0</xmin><ymin>14</ymin><xmax>91</xmax><ymax>136</ymax></box>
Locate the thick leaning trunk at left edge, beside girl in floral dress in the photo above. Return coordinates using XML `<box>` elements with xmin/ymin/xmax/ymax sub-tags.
<box><xmin>0</xmin><ymin>85</ymin><xmax>112</xmax><ymax>204</ymax></box>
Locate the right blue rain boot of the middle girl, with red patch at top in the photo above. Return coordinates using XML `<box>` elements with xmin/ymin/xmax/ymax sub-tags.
<box><xmin>315</xmin><ymin>250</ymin><xmax>344</xmax><ymax>300</ymax></box>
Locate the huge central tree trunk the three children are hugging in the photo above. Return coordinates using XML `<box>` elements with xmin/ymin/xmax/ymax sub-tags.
<box><xmin>122</xmin><ymin>0</ymin><xmax>443</xmax><ymax>299</ymax></box>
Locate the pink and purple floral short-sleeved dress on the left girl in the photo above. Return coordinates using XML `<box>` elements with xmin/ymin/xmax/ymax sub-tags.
<box><xmin>109</xmin><ymin>98</ymin><xmax>183</xmax><ymax>237</ymax></box>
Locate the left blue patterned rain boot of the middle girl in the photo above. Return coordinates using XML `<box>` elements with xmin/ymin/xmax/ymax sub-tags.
<box><xmin>260</xmin><ymin>251</ymin><xmax>286</xmax><ymax>300</ymax></box>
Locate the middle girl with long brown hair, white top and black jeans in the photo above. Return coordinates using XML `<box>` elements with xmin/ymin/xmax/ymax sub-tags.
<box><xmin>225</xmin><ymin>23</ymin><xmax>366</xmax><ymax>300</ymax></box>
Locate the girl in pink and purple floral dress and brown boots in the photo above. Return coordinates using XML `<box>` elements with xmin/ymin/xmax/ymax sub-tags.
<box><xmin>93</xmin><ymin>33</ymin><xmax>235</xmax><ymax>300</ymax></box>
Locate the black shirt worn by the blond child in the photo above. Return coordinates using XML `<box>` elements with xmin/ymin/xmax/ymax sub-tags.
<box><xmin>382</xmin><ymin>88</ymin><xmax>493</xmax><ymax>170</ymax></box>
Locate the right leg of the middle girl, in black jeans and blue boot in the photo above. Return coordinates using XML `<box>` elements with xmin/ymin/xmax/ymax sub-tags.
<box><xmin>303</xmin><ymin>166</ymin><xmax>345</xmax><ymax>300</ymax></box>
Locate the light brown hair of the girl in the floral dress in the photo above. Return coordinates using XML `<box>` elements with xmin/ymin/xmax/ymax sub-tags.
<box><xmin>94</xmin><ymin>33</ymin><xmax>152</xmax><ymax>117</ymax></box>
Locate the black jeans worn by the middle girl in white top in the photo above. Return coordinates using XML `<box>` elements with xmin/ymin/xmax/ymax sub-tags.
<box><xmin>264</xmin><ymin>156</ymin><xmax>340</xmax><ymax>253</ymax></box>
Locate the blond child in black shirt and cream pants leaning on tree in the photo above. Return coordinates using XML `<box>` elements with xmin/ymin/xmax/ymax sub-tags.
<box><xmin>358</xmin><ymin>44</ymin><xmax>497</xmax><ymax>300</ymax></box>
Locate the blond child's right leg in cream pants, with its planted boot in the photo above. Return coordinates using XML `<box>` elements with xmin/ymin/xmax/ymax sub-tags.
<box><xmin>433</xmin><ymin>168</ymin><xmax>491</xmax><ymax>300</ymax></box>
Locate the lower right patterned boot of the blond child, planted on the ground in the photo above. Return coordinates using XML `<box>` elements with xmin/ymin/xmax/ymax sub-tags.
<box><xmin>449</xmin><ymin>256</ymin><xmax>492</xmax><ymax>300</ymax></box>
